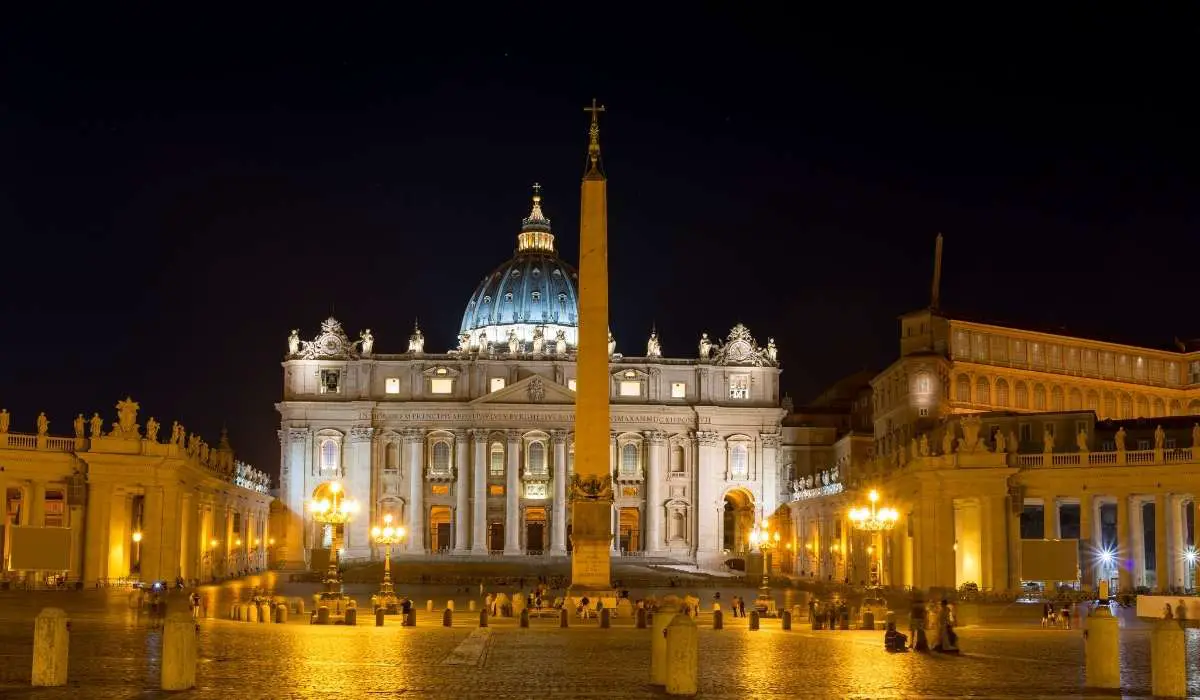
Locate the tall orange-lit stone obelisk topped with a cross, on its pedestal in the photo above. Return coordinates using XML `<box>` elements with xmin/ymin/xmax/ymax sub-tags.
<box><xmin>571</xmin><ymin>100</ymin><xmax>612</xmax><ymax>594</ymax></box>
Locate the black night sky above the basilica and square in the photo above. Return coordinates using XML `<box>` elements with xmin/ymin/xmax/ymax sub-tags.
<box><xmin>0</xmin><ymin>10</ymin><xmax>1200</xmax><ymax>480</ymax></box>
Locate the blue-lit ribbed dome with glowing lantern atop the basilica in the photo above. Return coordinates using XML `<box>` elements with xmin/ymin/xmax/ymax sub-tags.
<box><xmin>458</xmin><ymin>185</ymin><xmax>580</xmax><ymax>353</ymax></box>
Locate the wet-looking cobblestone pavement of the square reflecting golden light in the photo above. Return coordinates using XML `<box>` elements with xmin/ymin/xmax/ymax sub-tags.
<box><xmin>0</xmin><ymin>581</ymin><xmax>1200</xmax><ymax>700</ymax></box>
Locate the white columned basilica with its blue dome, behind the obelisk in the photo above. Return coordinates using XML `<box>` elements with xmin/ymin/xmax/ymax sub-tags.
<box><xmin>277</xmin><ymin>188</ymin><xmax>790</xmax><ymax>567</ymax></box>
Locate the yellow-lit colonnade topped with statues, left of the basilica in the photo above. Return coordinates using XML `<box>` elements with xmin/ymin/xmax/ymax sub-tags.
<box><xmin>0</xmin><ymin>399</ymin><xmax>274</xmax><ymax>587</ymax></box>
